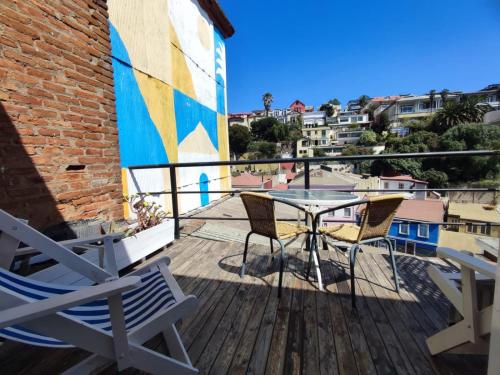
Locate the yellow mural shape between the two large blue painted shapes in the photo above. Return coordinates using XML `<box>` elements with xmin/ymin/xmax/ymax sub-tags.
<box><xmin>134</xmin><ymin>70</ymin><xmax>177</xmax><ymax>163</ymax></box>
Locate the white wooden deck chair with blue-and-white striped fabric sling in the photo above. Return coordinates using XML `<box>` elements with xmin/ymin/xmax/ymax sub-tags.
<box><xmin>0</xmin><ymin>210</ymin><xmax>197</xmax><ymax>374</ymax></box>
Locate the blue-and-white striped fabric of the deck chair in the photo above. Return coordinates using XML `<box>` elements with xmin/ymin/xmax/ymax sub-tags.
<box><xmin>0</xmin><ymin>268</ymin><xmax>175</xmax><ymax>348</ymax></box>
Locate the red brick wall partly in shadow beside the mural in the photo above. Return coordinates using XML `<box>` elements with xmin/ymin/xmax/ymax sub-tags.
<box><xmin>0</xmin><ymin>0</ymin><xmax>123</xmax><ymax>234</ymax></box>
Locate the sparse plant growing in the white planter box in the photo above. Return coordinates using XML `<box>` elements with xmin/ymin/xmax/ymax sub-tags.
<box><xmin>123</xmin><ymin>194</ymin><xmax>167</xmax><ymax>236</ymax></box>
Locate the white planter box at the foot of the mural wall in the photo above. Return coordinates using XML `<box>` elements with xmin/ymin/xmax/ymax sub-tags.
<box><xmin>115</xmin><ymin>220</ymin><xmax>174</xmax><ymax>270</ymax></box>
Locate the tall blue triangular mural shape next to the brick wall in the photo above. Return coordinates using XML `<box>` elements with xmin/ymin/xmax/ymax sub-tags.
<box><xmin>109</xmin><ymin>22</ymin><xmax>168</xmax><ymax>168</ymax></box>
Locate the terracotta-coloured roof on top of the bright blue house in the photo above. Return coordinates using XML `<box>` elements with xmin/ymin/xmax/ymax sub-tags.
<box><xmin>396</xmin><ymin>199</ymin><xmax>444</xmax><ymax>223</ymax></box>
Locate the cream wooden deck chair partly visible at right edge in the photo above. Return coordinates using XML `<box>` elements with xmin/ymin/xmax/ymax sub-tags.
<box><xmin>427</xmin><ymin>247</ymin><xmax>496</xmax><ymax>355</ymax></box>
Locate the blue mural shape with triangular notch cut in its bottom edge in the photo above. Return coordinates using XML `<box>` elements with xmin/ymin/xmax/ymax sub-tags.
<box><xmin>174</xmin><ymin>89</ymin><xmax>219</xmax><ymax>151</ymax></box>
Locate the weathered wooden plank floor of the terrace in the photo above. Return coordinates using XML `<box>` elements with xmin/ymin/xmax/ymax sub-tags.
<box><xmin>0</xmin><ymin>237</ymin><xmax>487</xmax><ymax>375</ymax></box>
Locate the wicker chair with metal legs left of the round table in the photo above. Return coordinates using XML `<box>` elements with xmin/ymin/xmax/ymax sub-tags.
<box><xmin>240</xmin><ymin>193</ymin><xmax>311</xmax><ymax>297</ymax></box>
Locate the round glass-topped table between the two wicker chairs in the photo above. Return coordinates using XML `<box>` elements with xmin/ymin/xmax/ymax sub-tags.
<box><xmin>269</xmin><ymin>189</ymin><xmax>361</xmax><ymax>290</ymax></box>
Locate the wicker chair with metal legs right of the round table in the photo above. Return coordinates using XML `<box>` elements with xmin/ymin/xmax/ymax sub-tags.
<box><xmin>307</xmin><ymin>194</ymin><xmax>405</xmax><ymax>307</ymax></box>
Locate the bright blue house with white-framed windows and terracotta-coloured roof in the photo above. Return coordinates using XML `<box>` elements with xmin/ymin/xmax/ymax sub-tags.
<box><xmin>389</xmin><ymin>199</ymin><xmax>444</xmax><ymax>255</ymax></box>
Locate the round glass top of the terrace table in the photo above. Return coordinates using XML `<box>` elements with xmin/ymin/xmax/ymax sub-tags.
<box><xmin>269</xmin><ymin>189</ymin><xmax>360</xmax><ymax>205</ymax></box>
